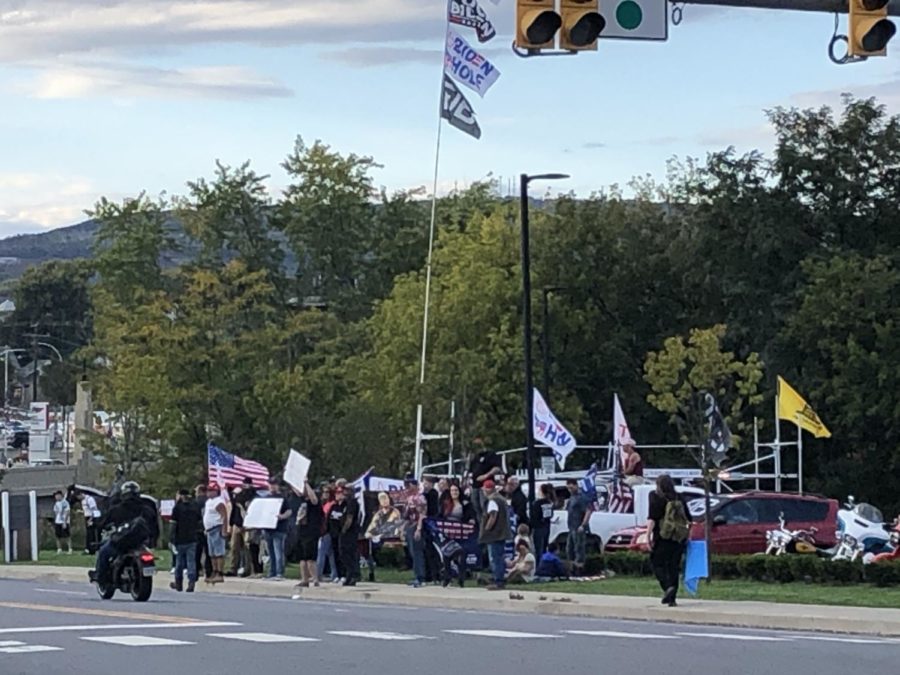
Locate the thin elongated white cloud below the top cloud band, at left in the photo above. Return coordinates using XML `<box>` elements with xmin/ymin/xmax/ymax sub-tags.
<box><xmin>27</xmin><ymin>63</ymin><xmax>293</xmax><ymax>99</ymax></box>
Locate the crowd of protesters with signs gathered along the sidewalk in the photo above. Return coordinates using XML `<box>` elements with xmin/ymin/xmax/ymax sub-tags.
<box><xmin>160</xmin><ymin>451</ymin><xmax>604</xmax><ymax>592</ymax></box>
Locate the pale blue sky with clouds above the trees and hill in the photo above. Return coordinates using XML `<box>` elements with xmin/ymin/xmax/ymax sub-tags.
<box><xmin>0</xmin><ymin>0</ymin><xmax>900</xmax><ymax>237</ymax></box>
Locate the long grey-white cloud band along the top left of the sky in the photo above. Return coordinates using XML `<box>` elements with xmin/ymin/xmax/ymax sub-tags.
<box><xmin>0</xmin><ymin>0</ymin><xmax>445</xmax><ymax>63</ymax></box>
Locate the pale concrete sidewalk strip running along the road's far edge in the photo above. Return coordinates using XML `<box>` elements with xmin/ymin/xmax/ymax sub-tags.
<box><xmin>0</xmin><ymin>565</ymin><xmax>900</xmax><ymax>637</ymax></box>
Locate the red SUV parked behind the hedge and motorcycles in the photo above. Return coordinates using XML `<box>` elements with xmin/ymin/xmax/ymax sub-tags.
<box><xmin>606</xmin><ymin>492</ymin><xmax>838</xmax><ymax>554</ymax></box>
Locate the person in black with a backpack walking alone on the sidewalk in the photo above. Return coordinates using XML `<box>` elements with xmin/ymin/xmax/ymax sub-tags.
<box><xmin>647</xmin><ymin>474</ymin><xmax>691</xmax><ymax>607</ymax></box>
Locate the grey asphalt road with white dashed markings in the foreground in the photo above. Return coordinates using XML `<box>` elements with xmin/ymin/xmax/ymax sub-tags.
<box><xmin>0</xmin><ymin>575</ymin><xmax>900</xmax><ymax>675</ymax></box>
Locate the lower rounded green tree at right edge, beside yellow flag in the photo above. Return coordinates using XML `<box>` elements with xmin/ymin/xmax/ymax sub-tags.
<box><xmin>779</xmin><ymin>254</ymin><xmax>900</xmax><ymax>513</ymax></box>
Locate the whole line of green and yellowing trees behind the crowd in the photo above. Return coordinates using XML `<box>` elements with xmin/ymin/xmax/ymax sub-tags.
<box><xmin>3</xmin><ymin>97</ymin><xmax>900</xmax><ymax>511</ymax></box>
